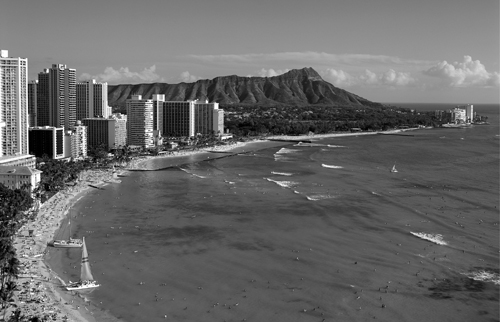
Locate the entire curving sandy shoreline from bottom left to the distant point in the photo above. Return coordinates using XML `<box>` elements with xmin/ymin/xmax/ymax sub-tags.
<box><xmin>6</xmin><ymin>129</ymin><xmax>415</xmax><ymax>322</ymax></box>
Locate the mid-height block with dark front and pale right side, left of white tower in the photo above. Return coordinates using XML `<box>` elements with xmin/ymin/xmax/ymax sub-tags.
<box><xmin>82</xmin><ymin>118</ymin><xmax>127</xmax><ymax>150</ymax></box>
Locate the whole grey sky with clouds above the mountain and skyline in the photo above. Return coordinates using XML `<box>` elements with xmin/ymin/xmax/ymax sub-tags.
<box><xmin>0</xmin><ymin>0</ymin><xmax>500</xmax><ymax>104</ymax></box>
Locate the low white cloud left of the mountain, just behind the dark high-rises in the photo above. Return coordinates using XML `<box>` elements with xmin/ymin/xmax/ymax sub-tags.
<box><xmin>79</xmin><ymin>65</ymin><xmax>164</xmax><ymax>83</ymax></box>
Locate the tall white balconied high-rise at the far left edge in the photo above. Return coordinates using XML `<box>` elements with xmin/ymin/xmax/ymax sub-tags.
<box><xmin>0</xmin><ymin>50</ymin><xmax>28</xmax><ymax>158</ymax></box>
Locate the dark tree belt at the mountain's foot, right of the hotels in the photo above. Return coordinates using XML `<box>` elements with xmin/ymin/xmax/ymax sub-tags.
<box><xmin>223</xmin><ymin>105</ymin><xmax>440</xmax><ymax>136</ymax></box>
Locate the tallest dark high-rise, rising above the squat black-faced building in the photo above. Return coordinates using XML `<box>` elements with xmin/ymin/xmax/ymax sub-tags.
<box><xmin>37</xmin><ymin>64</ymin><xmax>76</xmax><ymax>130</ymax></box>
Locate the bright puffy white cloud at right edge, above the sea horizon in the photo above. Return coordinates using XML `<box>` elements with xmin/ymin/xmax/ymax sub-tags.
<box><xmin>423</xmin><ymin>56</ymin><xmax>500</xmax><ymax>87</ymax></box>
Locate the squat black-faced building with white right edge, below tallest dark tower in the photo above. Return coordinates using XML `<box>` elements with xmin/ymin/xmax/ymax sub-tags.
<box><xmin>29</xmin><ymin>126</ymin><xmax>65</xmax><ymax>159</ymax></box>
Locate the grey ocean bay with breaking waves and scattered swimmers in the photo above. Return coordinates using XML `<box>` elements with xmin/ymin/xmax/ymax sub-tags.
<box><xmin>48</xmin><ymin>104</ymin><xmax>500</xmax><ymax>321</ymax></box>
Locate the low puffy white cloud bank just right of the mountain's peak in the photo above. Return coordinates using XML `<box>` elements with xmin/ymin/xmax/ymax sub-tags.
<box><xmin>319</xmin><ymin>68</ymin><xmax>416</xmax><ymax>87</ymax></box>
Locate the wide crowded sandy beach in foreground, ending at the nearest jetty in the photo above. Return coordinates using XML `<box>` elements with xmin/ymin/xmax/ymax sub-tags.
<box><xmin>6</xmin><ymin>169</ymin><xmax>124</xmax><ymax>322</ymax></box>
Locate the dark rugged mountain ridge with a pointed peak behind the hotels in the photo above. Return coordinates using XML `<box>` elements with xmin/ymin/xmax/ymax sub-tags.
<box><xmin>108</xmin><ymin>67</ymin><xmax>382</xmax><ymax>106</ymax></box>
